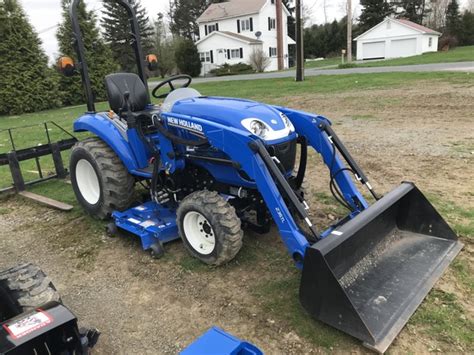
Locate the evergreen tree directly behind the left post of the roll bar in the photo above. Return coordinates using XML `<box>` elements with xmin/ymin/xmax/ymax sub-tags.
<box><xmin>56</xmin><ymin>0</ymin><xmax>117</xmax><ymax>105</ymax></box>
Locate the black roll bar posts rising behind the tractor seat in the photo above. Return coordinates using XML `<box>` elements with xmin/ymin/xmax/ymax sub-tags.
<box><xmin>69</xmin><ymin>0</ymin><xmax>150</xmax><ymax>113</ymax></box>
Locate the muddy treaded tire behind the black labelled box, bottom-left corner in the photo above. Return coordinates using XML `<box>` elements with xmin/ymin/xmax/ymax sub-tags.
<box><xmin>0</xmin><ymin>264</ymin><xmax>61</xmax><ymax>322</ymax></box>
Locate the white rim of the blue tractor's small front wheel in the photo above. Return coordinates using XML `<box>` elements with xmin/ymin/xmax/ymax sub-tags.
<box><xmin>183</xmin><ymin>211</ymin><xmax>216</xmax><ymax>255</ymax></box>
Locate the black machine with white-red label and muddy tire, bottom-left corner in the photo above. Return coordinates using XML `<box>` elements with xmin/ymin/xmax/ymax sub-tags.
<box><xmin>0</xmin><ymin>264</ymin><xmax>100</xmax><ymax>355</ymax></box>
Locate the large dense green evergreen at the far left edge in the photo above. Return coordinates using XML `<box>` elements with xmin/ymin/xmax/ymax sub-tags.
<box><xmin>0</xmin><ymin>0</ymin><xmax>60</xmax><ymax>114</ymax></box>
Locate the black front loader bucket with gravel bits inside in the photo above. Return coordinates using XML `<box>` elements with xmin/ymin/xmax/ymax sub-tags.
<box><xmin>300</xmin><ymin>183</ymin><xmax>462</xmax><ymax>353</ymax></box>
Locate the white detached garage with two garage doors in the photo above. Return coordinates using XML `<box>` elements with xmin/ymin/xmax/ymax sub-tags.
<box><xmin>354</xmin><ymin>18</ymin><xmax>441</xmax><ymax>60</ymax></box>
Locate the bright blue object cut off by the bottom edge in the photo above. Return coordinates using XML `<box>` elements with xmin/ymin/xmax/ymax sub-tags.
<box><xmin>181</xmin><ymin>327</ymin><xmax>263</xmax><ymax>355</ymax></box>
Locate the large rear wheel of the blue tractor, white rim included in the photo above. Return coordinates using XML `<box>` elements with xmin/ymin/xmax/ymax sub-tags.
<box><xmin>70</xmin><ymin>138</ymin><xmax>135</xmax><ymax>220</ymax></box>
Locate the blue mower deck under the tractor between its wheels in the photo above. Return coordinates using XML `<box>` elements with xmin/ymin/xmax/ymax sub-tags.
<box><xmin>112</xmin><ymin>201</ymin><xmax>179</xmax><ymax>250</ymax></box>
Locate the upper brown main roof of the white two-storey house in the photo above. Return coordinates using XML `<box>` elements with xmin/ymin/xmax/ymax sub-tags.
<box><xmin>196</xmin><ymin>0</ymin><xmax>266</xmax><ymax>23</ymax></box>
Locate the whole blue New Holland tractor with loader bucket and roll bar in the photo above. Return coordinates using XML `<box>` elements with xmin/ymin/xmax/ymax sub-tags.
<box><xmin>63</xmin><ymin>0</ymin><xmax>462</xmax><ymax>352</ymax></box>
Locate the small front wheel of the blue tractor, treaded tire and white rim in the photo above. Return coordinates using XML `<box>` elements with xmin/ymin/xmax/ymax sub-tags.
<box><xmin>177</xmin><ymin>190</ymin><xmax>243</xmax><ymax>265</ymax></box>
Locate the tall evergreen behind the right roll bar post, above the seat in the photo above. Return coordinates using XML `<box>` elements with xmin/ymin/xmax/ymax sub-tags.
<box><xmin>101</xmin><ymin>0</ymin><xmax>153</xmax><ymax>72</ymax></box>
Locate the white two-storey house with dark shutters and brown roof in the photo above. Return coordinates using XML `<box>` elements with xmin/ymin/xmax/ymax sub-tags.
<box><xmin>196</xmin><ymin>0</ymin><xmax>295</xmax><ymax>75</ymax></box>
